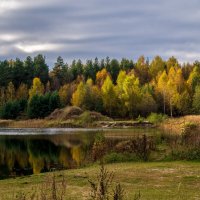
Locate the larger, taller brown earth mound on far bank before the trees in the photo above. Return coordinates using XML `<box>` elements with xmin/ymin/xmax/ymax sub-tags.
<box><xmin>46</xmin><ymin>106</ymin><xmax>83</xmax><ymax>120</ymax></box>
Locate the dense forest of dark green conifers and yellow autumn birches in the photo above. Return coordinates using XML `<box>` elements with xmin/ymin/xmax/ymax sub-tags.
<box><xmin>0</xmin><ymin>54</ymin><xmax>200</xmax><ymax>119</ymax></box>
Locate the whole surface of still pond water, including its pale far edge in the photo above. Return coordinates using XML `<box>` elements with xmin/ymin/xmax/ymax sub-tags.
<box><xmin>0</xmin><ymin>129</ymin><xmax>159</xmax><ymax>179</ymax></box>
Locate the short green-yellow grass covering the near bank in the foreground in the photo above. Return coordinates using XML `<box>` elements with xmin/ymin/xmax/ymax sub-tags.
<box><xmin>0</xmin><ymin>162</ymin><xmax>200</xmax><ymax>200</ymax></box>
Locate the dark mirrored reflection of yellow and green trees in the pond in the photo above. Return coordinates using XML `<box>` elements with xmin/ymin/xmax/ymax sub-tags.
<box><xmin>0</xmin><ymin>132</ymin><xmax>97</xmax><ymax>178</ymax></box>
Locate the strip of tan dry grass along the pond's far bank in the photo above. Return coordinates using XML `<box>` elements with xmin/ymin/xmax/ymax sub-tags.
<box><xmin>0</xmin><ymin>115</ymin><xmax>200</xmax><ymax>134</ymax></box>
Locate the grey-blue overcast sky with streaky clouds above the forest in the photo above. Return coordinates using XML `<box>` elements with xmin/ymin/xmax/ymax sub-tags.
<box><xmin>0</xmin><ymin>0</ymin><xmax>200</xmax><ymax>65</ymax></box>
